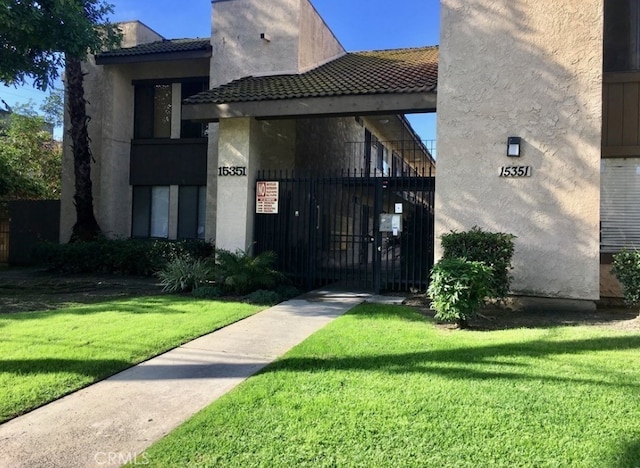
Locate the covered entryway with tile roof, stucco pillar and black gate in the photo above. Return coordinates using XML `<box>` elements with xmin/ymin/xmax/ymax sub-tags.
<box><xmin>182</xmin><ymin>47</ymin><xmax>438</xmax><ymax>291</ymax></box>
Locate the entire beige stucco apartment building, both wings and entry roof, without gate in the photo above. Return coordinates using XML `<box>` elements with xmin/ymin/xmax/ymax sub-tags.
<box><xmin>61</xmin><ymin>0</ymin><xmax>640</xmax><ymax>300</ymax></box>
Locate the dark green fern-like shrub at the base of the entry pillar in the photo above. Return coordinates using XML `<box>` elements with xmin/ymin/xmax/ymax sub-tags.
<box><xmin>216</xmin><ymin>249</ymin><xmax>285</xmax><ymax>295</ymax></box>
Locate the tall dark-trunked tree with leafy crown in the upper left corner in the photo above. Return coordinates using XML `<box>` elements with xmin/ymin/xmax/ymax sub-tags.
<box><xmin>0</xmin><ymin>0</ymin><xmax>121</xmax><ymax>241</ymax></box>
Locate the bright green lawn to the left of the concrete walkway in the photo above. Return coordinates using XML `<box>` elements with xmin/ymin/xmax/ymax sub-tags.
<box><xmin>0</xmin><ymin>296</ymin><xmax>261</xmax><ymax>422</ymax></box>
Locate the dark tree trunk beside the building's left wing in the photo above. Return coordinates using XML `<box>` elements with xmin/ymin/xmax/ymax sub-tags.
<box><xmin>66</xmin><ymin>57</ymin><xmax>100</xmax><ymax>242</ymax></box>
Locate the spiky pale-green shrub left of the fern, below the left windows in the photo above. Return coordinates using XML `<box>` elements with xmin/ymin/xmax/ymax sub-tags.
<box><xmin>157</xmin><ymin>255</ymin><xmax>213</xmax><ymax>293</ymax></box>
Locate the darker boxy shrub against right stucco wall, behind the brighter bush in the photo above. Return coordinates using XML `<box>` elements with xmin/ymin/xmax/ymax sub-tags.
<box><xmin>441</xmin><ymin>226</ymin><xmax>516</xmax><ymax>299</ymax></box>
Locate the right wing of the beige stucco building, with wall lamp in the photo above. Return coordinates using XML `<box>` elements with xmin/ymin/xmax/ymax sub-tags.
<box><xmin>436</xmin><ymin>0</ymin><xmax>640</xmax><ymax>299</ymax></box>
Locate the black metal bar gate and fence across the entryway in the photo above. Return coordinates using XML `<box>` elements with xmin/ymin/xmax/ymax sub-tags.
<box><xmin>255</xmin><ymin>171</ymin><xmax>435</xmax><ymax>292</ymax></box>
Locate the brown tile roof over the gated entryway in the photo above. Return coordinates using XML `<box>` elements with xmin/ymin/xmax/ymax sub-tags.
<box><xmin>185</xmin><ymin>47</ymin><xmax>438</xmax><ymax>104</ymax></box>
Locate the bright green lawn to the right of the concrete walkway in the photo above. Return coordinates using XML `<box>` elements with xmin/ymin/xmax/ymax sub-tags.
<box><xmin>146</xmin><ymin>305</ymin><xmax>640</xmax><ymax>467</ymax></box>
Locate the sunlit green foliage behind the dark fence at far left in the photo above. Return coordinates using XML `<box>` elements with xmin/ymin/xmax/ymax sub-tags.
<box><xmin>0</xmin><ymin>113</ymin><xmax>62</xmax><ymax>200</ymax></box>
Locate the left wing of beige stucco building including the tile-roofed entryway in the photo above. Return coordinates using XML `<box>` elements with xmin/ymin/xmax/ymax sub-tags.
<box><xmin>61</xmin><ymin>0</ymin><xmax>438</xmax><ymax>288</ymax></box>
